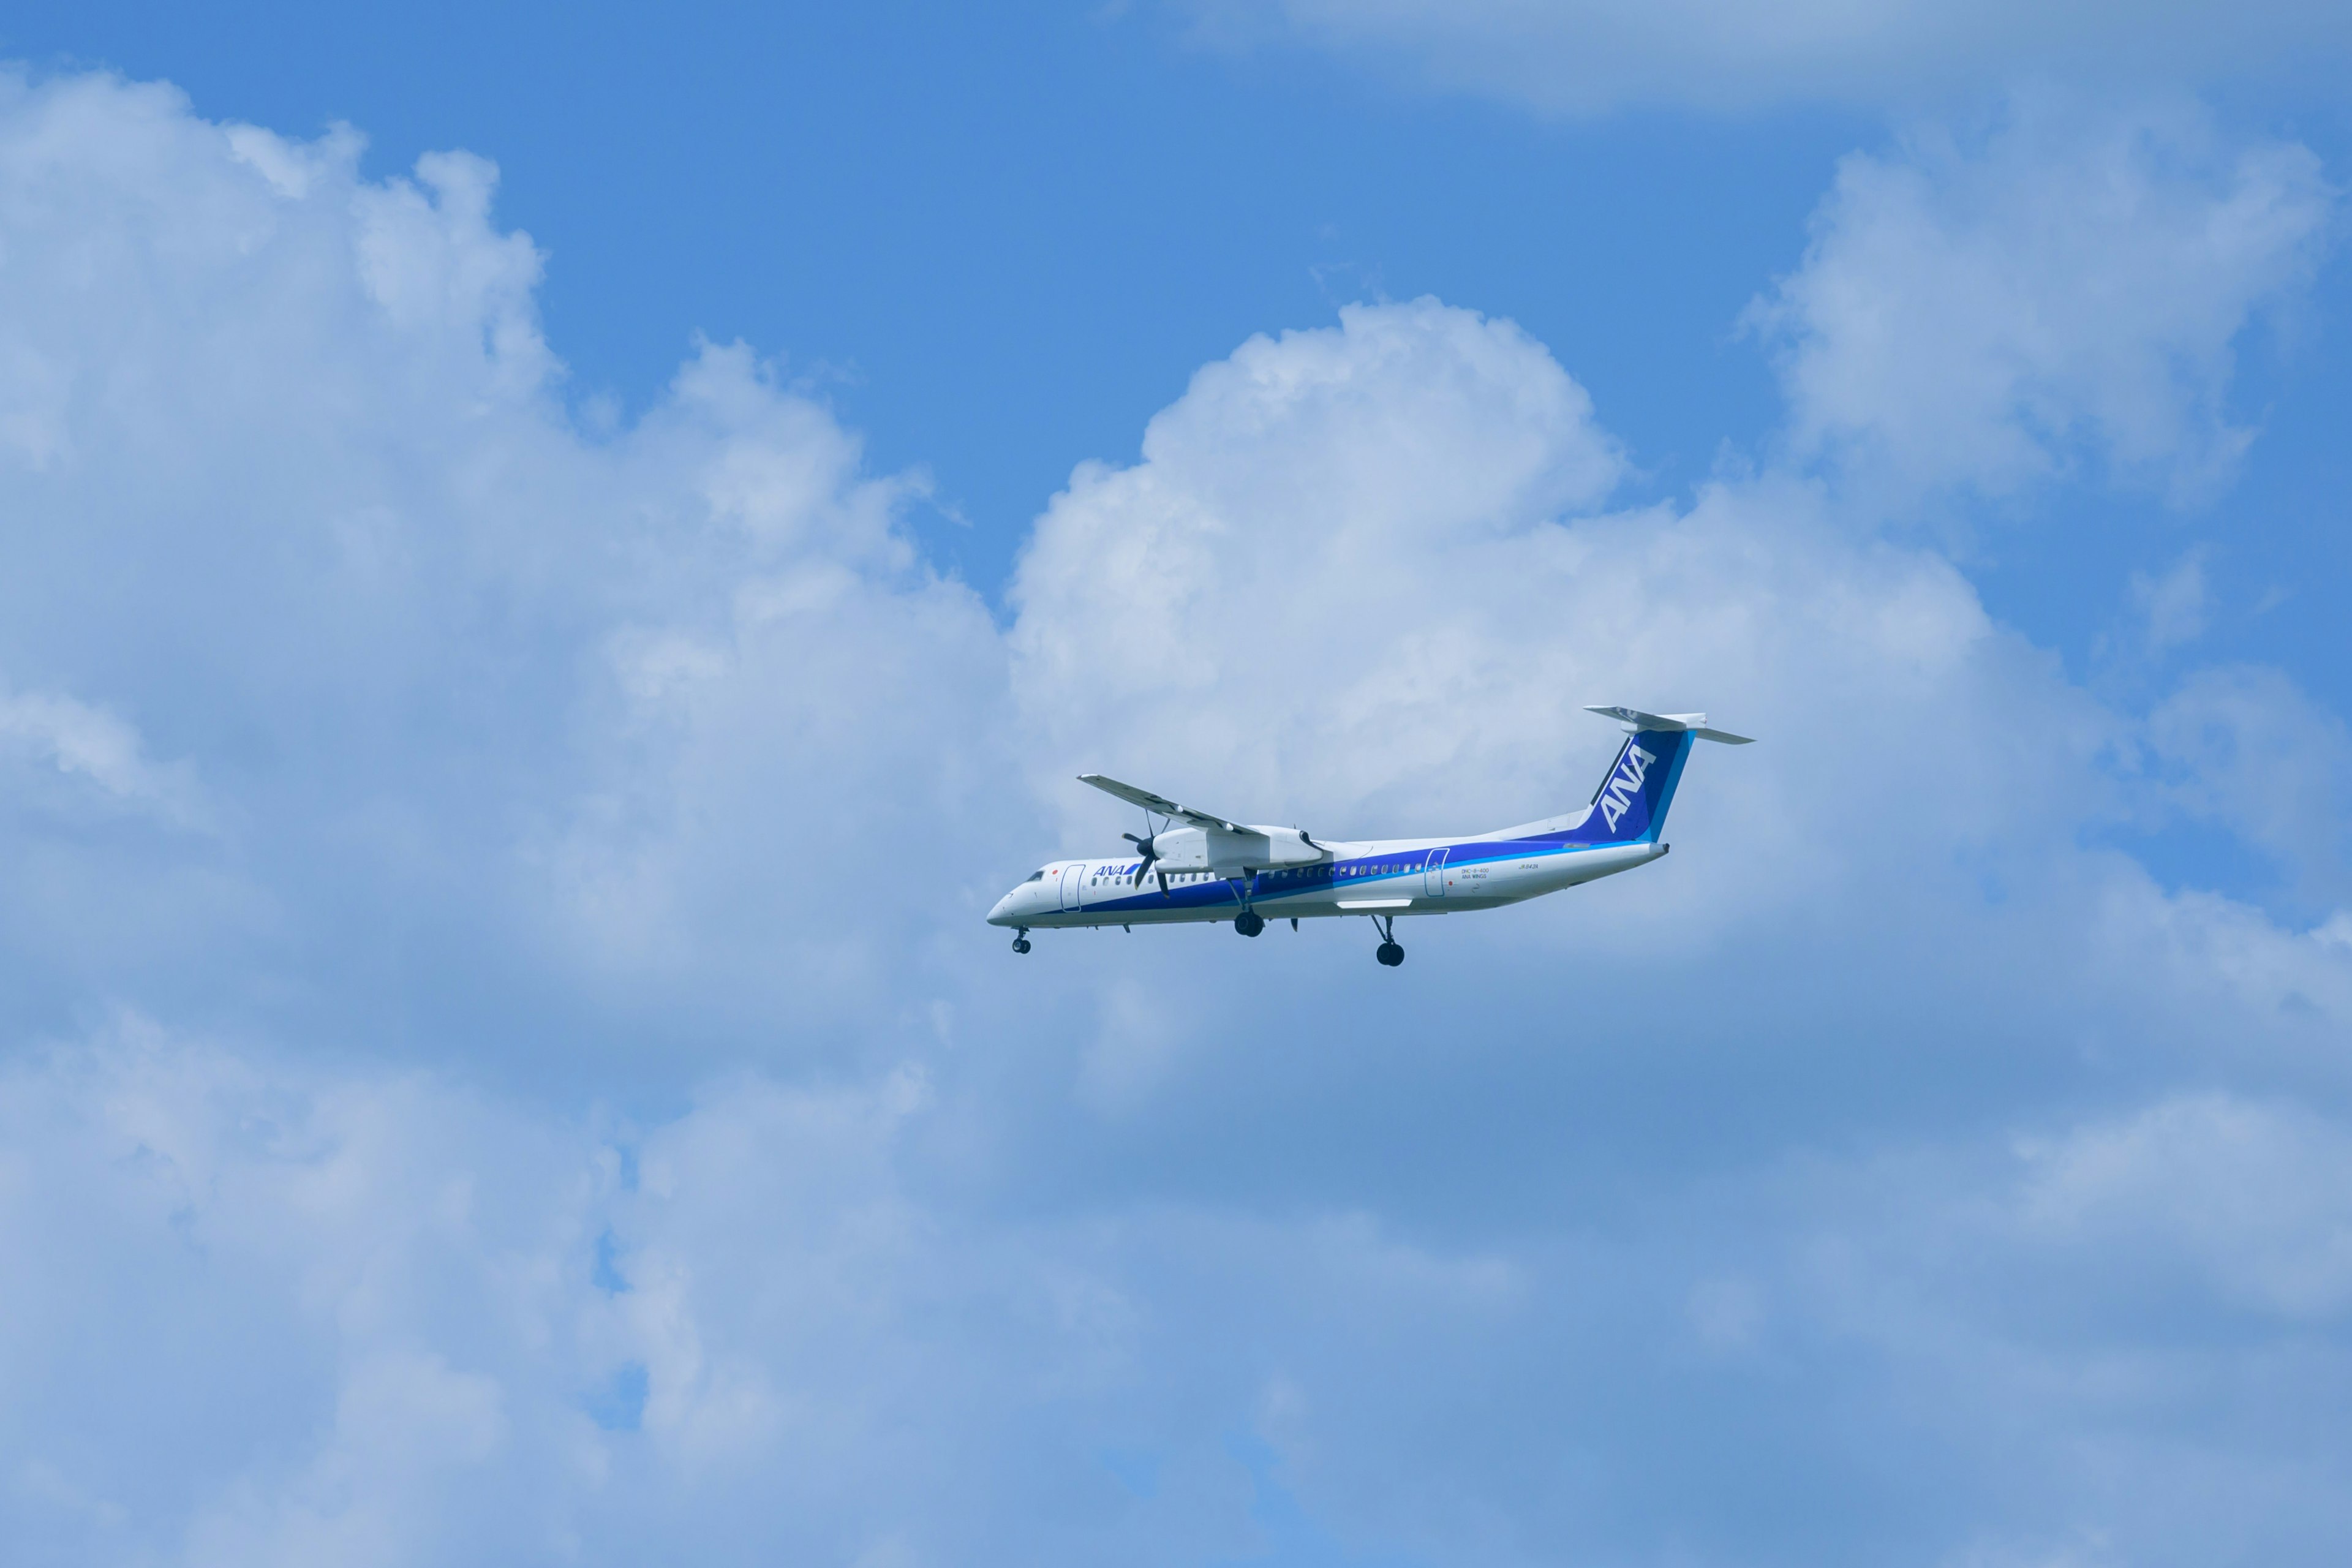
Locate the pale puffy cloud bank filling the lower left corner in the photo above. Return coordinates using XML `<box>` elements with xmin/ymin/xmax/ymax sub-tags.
<box><xmin>0</xmin><ymin>1020</ymin><xmax>1279</xmax><ymax>1563</ymax></box>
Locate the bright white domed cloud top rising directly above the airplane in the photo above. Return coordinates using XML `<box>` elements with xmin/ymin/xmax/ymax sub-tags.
<box><xmin>1011</xmin><ymin>301</ymin><xmax>1623</xmax><ymax>832</ymax></box>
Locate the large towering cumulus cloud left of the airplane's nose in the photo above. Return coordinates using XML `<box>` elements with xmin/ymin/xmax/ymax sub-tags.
<box><xmin>0</xmin><ymin>67</ymin><xmax>1005</xmax><ymax>1067</ymax></box>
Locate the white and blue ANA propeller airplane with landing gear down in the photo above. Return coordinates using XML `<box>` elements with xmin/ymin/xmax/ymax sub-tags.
<box><xmin>988</xmin><ymin>707</ymin><xmax>1750</xmax><ymax>968</ymax></box>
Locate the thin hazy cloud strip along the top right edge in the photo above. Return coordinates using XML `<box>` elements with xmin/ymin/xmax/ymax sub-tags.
<box><xmin>1181</xmin><ymin>0</ymin><xmax>2352</xmax><ymax>115</ymax></box>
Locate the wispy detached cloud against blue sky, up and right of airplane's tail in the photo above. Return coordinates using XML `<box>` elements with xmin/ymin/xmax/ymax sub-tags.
<box><xmin>1750</xmin><ymin>99</ymin><xmax>2333</xmax><ymax>508</ymax></box>
